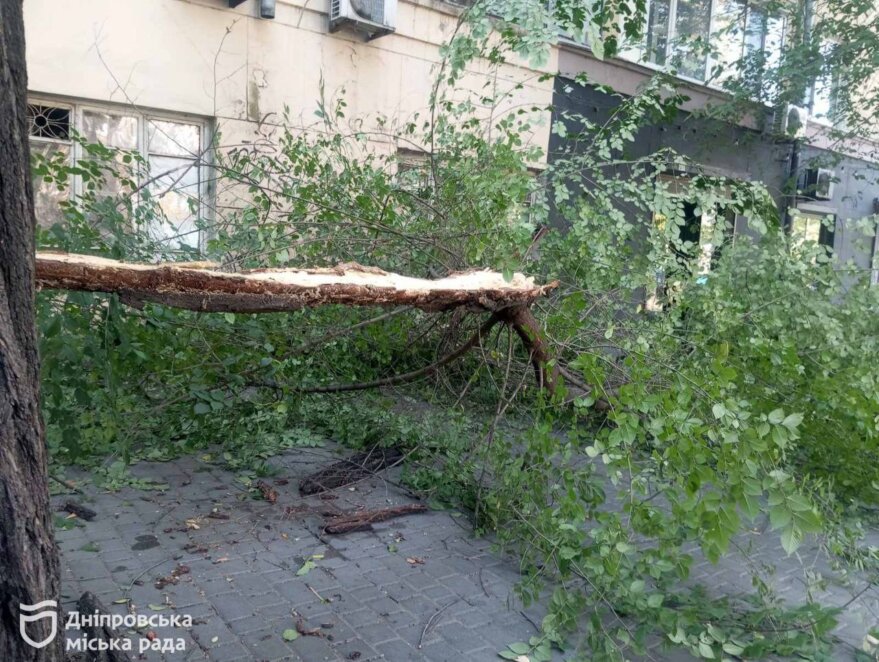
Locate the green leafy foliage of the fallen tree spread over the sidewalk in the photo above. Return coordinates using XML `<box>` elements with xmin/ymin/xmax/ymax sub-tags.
<box><xmin>29</xmin><ymin>3</ymin><xmax>879</xmax><ymax>660</ymax></box>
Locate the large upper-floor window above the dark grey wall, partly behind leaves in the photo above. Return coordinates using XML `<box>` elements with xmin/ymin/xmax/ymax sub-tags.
<box><xmin>621</xmin><ymin>0</ymin><xmax>785</xmax><ymax>82</ymax></box>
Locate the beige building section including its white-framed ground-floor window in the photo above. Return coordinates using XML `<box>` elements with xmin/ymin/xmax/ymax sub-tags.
<box><xmin>25</xmin><ymin>0</ymin><xmax>557</xmax><ymax>245</ymax></box>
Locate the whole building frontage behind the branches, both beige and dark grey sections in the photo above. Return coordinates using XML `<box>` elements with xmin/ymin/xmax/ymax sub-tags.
<box><xmin>25</xmin><ymin>0</ymin><xmax>879</xmax><ymax>280</ymax></box>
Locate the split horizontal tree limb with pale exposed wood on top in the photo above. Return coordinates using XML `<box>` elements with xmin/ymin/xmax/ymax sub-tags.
<box><xmin>36</xmin><ymin>252</ymin><xmax>557</xmax><ymax>313</ymax></box>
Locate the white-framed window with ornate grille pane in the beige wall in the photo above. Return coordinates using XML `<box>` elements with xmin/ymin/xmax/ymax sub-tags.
<box><xmin>28</xmin><ymin>100</ymin><xmax>206</xmax><ymax>252</ymax></box>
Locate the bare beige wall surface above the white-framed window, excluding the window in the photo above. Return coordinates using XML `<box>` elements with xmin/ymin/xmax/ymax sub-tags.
<box><xmin>25</xmin><ymin>0</ymin><xmax>557</xmax><ymax>153</ymax></box>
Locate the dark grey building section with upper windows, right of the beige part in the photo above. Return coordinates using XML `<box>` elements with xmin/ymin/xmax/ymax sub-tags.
<box><xmin>549</xmin><ymin>0</ymin><xmax>879</xmax><ymax>283</ymax></box>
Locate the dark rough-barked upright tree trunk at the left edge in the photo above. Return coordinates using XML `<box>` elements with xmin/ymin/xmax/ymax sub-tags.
<box><xmin>0</xmin><ymin>0</ymin><xmax>64</xmax><ymax>662</ymax></box>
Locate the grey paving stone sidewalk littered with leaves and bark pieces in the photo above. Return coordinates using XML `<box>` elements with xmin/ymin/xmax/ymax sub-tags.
<box><xmin>55</xmin><ymin>446</ymin><xmax>879</xmax><ymax>662</ymax></box>
